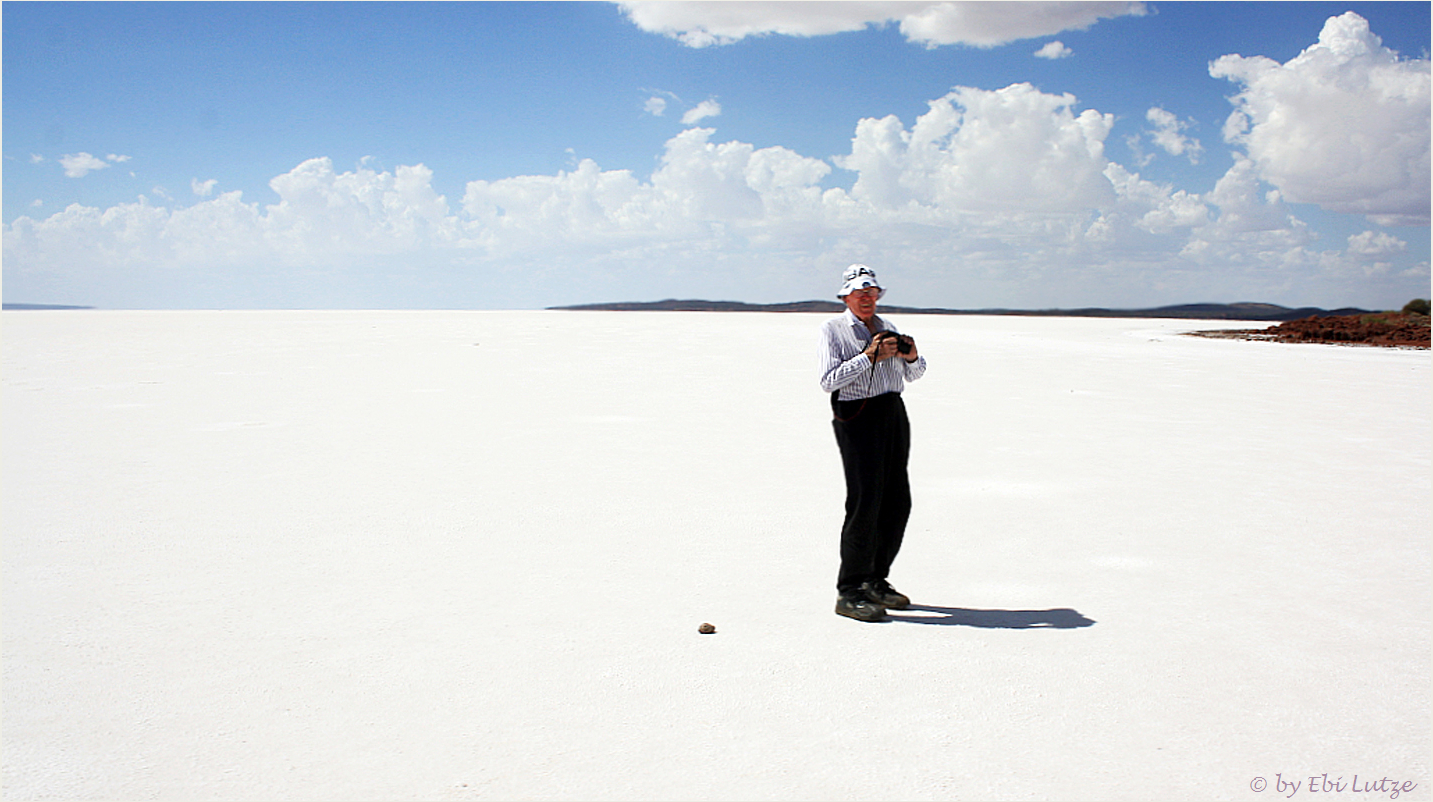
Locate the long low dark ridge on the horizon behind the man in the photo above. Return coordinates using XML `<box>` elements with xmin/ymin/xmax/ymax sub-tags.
<box><xmin>549</xmin><ymin>299</ymin><xmax>1370</xmax><ymax>321</ymax></box>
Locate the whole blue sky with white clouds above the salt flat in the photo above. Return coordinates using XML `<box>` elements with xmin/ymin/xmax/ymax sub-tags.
<box><xmin>0</xmin><ymin>1</ymin><xmax>1430</xmax><ymax>308</ymax></box>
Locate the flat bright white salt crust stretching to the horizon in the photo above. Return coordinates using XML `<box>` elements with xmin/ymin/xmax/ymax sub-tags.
<box><xmin>0</xmin><ymin>311</ymin><xmax>1433</xmax><ymax>799</ymax></box>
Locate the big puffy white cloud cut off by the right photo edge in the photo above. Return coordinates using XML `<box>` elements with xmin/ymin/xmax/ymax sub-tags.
<box><xmin>1209</xmin><ymin>11</ymin><xmax>1430</xmax><ymax>225</ymax></box>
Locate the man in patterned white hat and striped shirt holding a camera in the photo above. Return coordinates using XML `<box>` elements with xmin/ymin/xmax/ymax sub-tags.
<box><xmin>821</xmin><ymin>265</ymin><xmax>926</xmax><ymax>622</ymax></box>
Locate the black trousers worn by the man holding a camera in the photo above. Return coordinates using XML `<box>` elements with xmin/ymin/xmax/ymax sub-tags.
<box><xmin>831</xmin><ymin>392</ymin><xmax>910</xmax><ymax>591</ymax></box>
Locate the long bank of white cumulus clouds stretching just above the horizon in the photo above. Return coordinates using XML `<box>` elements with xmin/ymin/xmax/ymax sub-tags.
<box><xmin>8</xmin><ymin>52</ymin><xmax>1427</xmax><ymax>305</ymax></box>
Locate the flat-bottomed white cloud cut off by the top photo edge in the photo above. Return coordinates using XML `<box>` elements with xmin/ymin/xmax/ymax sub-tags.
<box><xmin>619</xmin><ymin>0</ymin><xmax>1146</xmax><ymax>47</ymax></box>
